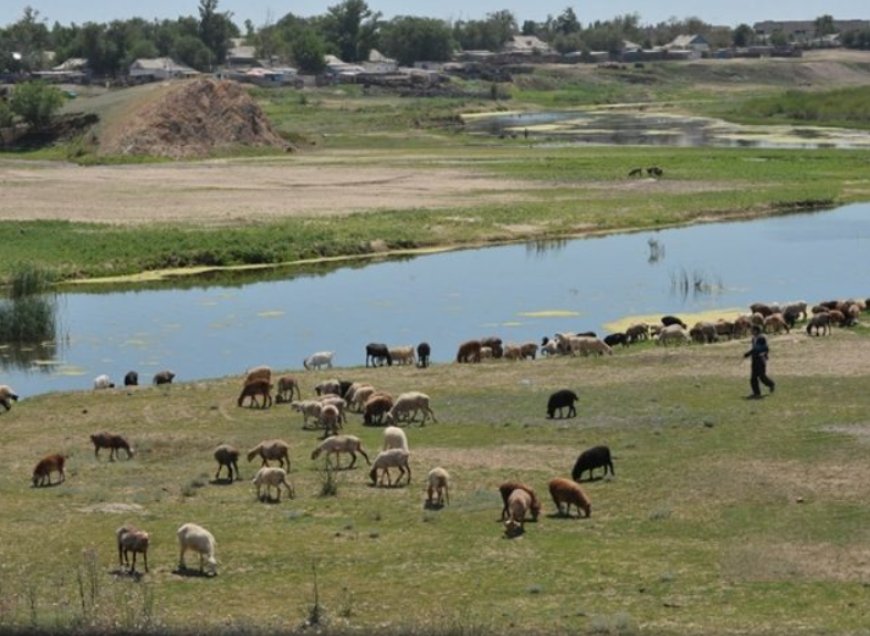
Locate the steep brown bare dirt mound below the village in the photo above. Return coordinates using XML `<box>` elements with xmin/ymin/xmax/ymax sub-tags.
<box><xmin>99</xmin><ymin>78</ymin><xmax>290</xmax><ymax>159</ymax></box>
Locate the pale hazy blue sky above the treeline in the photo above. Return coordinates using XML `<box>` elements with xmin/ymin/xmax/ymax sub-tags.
<box><xmin>0</xmin><ymin>0</ymin><xmax>870</xmax><ymax>28</ymax></box>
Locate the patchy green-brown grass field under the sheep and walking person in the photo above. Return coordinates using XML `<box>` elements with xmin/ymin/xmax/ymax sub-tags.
<box><xmin>0</xmin><ymin>327</ymin><xmax>870</xmax><ymax>634</ymax></box>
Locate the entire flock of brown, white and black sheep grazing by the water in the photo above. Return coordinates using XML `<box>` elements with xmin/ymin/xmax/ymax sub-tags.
<box><xmin>0</xmin><ymin>300</ymin><xmax>867</xmax><ymax>574</ymax></box>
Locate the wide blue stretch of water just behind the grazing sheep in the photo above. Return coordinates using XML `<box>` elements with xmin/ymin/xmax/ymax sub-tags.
<box><xmin>0</xmin><ymin>204</ymin><xmax>870</xmax><ymax>396</ymax></box>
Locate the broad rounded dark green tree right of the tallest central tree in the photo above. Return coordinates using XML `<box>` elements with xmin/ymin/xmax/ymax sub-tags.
<box><xmin>381</xmin><ymin>16</ymin><xmax>453</xmax><ymax>66</ymax></box>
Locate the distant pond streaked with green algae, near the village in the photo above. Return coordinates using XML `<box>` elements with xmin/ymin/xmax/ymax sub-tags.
<box><xmin>464</xmin><ymin>109</ymin><xmax>870</xmax><ymax>148</ymax></box>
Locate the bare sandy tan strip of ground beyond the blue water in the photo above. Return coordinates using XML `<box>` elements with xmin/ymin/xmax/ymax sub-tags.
<box><xmin>0</xmin><ymin>161</ymin><xmax>545</xmax><ymax>224</ymax></box>
